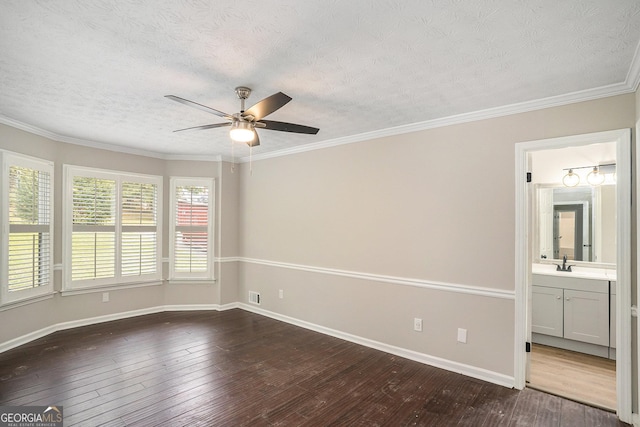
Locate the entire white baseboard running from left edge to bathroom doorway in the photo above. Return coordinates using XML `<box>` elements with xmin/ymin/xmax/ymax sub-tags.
<box><xmin>0</xmin><ymin>303</ymin><xmax>515</xmax><ymax>388</ymax></box>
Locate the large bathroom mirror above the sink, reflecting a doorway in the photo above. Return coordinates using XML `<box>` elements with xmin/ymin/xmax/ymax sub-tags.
<box><xmin>536</xmin><ymin>184</ymin><xmax>616</xmax><ymax>264</ymax></box>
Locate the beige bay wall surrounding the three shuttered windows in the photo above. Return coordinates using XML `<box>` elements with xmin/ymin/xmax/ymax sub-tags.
<box><xmin>0</xmin><ymin>125</ymin><xmax>238</xmax><ymax>345</ymax></box>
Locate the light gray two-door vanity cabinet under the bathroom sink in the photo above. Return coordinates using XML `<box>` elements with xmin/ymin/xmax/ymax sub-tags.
<box><xmin>532</xmin><ymin>274</ymin><xmax>615</xmax><ymax>357</ymax></box>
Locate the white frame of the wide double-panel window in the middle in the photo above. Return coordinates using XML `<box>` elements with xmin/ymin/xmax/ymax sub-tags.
<box><xmin>62</xmin><ymin>164</ymin><xmax>163</xmax><ymax>291</ymax></box>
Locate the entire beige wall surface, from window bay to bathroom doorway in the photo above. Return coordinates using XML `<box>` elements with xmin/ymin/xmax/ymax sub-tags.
<box><xmin>0</xmin><ymin>94</ymin><xmax>640</xmax><ymax>400</ymax></box>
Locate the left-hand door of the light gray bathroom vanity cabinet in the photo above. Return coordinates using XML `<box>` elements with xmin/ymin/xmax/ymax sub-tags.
<box><xmin>531</xmin><ymin>286</ymin><xmax>563</xmax><ymax>337</ymax></box>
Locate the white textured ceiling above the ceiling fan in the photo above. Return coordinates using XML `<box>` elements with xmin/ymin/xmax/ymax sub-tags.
<box><xmin>0</xmin><ymin>0</ymin><xmax>640</xmax><ymax>159</ymax></box>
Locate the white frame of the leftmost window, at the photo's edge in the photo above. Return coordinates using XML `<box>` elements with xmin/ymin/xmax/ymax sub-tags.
<box><xmin>0</xmin><ymin>150</ymin><xmax>55</xmax><ymax>306</ymax></box>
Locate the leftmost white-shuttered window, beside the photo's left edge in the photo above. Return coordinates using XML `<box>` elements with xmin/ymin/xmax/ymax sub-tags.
<box><xmin>0</xmin><ymin>152</ymin><xmax>53</xmax><ymax>304</ymax></box>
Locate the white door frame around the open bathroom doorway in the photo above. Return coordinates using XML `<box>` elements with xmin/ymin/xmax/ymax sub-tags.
<box><xmin>514</xmin><ymin>128</ymin><xmax>632</xmax><ymax>423</ymax></box>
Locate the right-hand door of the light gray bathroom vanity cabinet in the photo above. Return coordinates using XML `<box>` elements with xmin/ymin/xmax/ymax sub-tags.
<box><xmin>564</xmin><ymin>289</ymin><xmax>609</xmax><ymax>347</ymax></box>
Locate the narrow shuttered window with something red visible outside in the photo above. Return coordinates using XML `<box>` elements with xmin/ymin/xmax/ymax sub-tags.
<box><xmin>170</xmin><ymin>178</ymin><xmax>214</xmax><ymax>280</ymax></box>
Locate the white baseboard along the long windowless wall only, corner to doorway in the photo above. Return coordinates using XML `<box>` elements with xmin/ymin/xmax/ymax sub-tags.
<box><xmin>238</xmin><ymin>303</ymin><xmax>515</xmax><ymax>388</ymax></box>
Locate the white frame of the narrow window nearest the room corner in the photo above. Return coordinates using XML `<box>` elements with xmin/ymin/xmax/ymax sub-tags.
<box><xmin>169</xmin><ymin>176</ymin><xmax>216</xmax><ymax>282</ymax></box>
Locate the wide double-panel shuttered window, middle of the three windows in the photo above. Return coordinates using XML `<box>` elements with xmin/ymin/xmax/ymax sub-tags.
<box><xmin>63</xmin><ymin>166</ymin><xmax>162</xmax><ymax>289</ymax></box>
